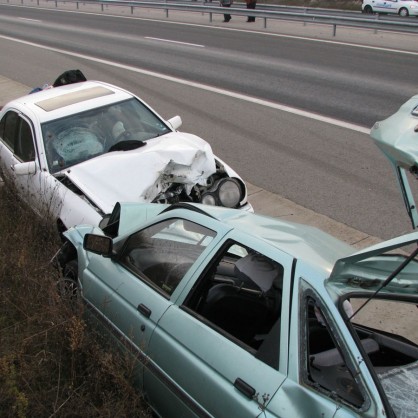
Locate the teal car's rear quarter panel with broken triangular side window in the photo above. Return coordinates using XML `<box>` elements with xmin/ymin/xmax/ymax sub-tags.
<box><xmin>272</xmin><ymin>274</ymin><xmax>392</xmax><ymax>418</ymax></box>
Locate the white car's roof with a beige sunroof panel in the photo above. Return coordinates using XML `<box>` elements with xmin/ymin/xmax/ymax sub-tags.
<box><xmin>6</xmin><ymin>81</ymin><xmax>133</xmax><ymax>123</ymax></box>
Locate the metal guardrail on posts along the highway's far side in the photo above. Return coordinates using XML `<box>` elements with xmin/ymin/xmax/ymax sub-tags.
<box><xmin>0</xmin><ymin>0</ymin><xmax>418</xmax><ymax>36</ymax></box>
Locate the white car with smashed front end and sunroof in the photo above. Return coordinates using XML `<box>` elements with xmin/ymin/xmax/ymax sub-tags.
<box><xmin>0</xmin><ymin>76</ymin><xmax>252</xmax><ymax>232</ymax></box>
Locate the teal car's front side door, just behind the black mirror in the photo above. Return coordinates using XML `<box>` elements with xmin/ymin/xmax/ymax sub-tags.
<box><xmin>82</xmin><ymin>218</ymin><xmax>220</xmax><ymax>386</ymax></box>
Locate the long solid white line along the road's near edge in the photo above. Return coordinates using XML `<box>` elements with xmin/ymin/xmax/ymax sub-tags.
<box><xmin>0</xmin><ymin>35</ymin><xmax>370</xmax><ymax>134</ymax></box>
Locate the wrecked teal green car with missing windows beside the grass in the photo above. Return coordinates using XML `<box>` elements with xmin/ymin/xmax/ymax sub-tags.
<box><xmin>58</xmin><ymin>203</ymin><xmax>418</xmax><ymax>418</ymax></box>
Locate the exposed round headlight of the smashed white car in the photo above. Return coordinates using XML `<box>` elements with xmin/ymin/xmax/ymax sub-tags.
<box><xmin>201</xmin><ymin>177</ymin><xmax>242</xmax><ymax>208</ymax></box>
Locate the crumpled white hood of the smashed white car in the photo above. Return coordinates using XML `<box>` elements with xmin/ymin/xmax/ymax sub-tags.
<box><xmin>60</xmin><ymin>132</ymin><xmax>216</xmax><ymax>213</ymax></box>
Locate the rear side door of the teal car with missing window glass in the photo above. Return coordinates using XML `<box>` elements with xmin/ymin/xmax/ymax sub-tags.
<box><xmin>144</xmin><ymin>233</ymin><xmax>293</xmax><ymax>418</ymax></box>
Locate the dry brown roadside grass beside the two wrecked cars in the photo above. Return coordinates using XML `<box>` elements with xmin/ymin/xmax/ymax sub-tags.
<box><xmin>0</xmin><ymin>186</ymin><xmax>150</xmax><ymax>417</ymax></box>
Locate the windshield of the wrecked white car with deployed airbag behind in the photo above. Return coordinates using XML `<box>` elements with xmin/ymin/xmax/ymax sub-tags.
<box><xmin>42</xmin><ymin>98</ymin><xmax>171</xmax><ymax>173</ymax></box>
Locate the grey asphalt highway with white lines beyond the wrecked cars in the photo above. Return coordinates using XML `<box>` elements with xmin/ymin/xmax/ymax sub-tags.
<box><xmin>0</xmin><ymin>1</ymin><xmax>418</xmax><ymax>238</ymax></box>
